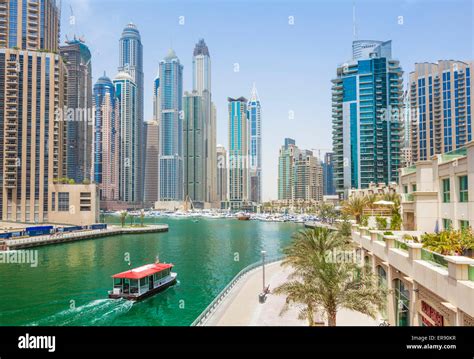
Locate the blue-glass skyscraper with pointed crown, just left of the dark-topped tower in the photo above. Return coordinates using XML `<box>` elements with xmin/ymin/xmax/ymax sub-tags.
<box><xmin>159</xmin><ymin>49</ymin><xmax>184</xmax><ymax>201</ymax></box>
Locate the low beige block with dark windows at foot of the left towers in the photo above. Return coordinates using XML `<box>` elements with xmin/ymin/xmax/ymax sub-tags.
<box><xmin>49</xmin><ymin>184</ymin><xmax>100</xmax><ymax>226</ymax></box>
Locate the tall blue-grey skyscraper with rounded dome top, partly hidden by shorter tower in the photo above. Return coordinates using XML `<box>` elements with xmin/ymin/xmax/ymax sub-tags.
<box><xmin>118</xmin><ymin>23</ymin><xmax>146</xmax><ymax>202</ymax></box>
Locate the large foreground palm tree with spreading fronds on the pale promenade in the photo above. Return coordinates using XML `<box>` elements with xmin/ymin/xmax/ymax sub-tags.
<box><xmin>274</xmin><ymin>228</ymin><xmax>387</xmax><ymax>326</ymax></box>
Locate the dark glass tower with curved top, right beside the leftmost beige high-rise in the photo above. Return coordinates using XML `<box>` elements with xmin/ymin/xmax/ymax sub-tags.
<box><xmin>60</xmin><ymin>38</ymin><xmax>93</xmax><ymax>183</ymax></box>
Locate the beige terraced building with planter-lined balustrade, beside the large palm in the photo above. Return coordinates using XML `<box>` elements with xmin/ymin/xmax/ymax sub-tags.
<box><xmin>352</xmin><ymin>225</ymin><xmax>474</xmax><ymax>326</ymax></box>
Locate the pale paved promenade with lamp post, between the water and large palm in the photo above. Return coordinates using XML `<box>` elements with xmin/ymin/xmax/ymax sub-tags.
<box><xmin>204</xmin><ymin>262</ymin><xmax>380</xmax><ymax>326</ymax></box>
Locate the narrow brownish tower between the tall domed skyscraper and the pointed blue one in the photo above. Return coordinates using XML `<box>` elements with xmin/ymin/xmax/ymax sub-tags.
<box><xmin>144</xmin><ymin>120</ymin><xmax>160</xmax><ymax>206</ymax></box>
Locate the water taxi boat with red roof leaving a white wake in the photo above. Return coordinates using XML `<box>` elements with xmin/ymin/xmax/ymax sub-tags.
<box><xmin>109</xmin><ymin>263</ymin><xmax>177</xmax><ymax>300</ymax></box>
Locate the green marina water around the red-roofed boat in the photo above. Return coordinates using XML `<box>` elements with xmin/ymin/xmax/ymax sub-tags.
<box><xmin>0</xmin><ymin>218</ymin><xmax>302</xmax><ymax>326</ymax></box>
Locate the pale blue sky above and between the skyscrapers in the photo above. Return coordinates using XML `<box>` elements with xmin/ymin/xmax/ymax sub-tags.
<box><xmin>61</xmin><ymin>0</ymin><xmax>474</xmax><ymax>200</ymax></box>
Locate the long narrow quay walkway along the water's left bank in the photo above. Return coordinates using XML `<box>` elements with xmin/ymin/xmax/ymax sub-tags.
<box><xmin>3</xmin><ymin>224</ymin><xmax>168</xmax><ymax>250</ymax></box>
